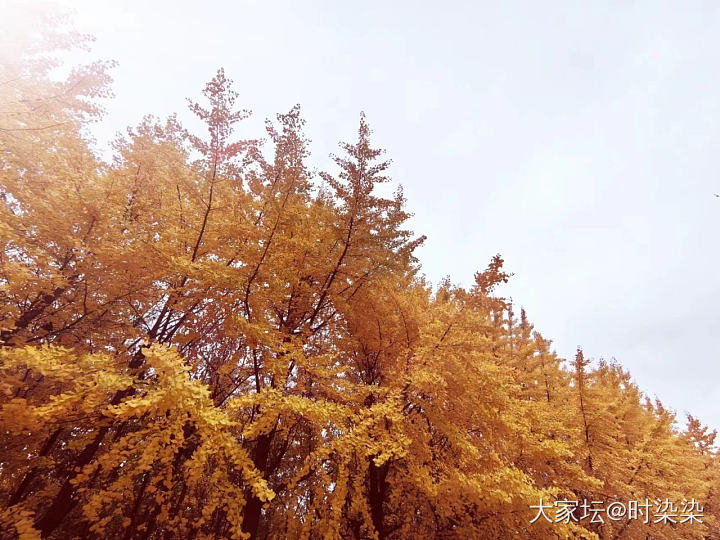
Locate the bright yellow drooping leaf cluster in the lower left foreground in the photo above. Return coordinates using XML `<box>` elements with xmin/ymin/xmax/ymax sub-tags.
<box><xmin>4</xmin><ymin>345</ymin><xmax>274</xmax><ymax>537</ymax></box>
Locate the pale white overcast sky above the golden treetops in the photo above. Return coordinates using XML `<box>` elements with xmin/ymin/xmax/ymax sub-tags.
<box><xmin>25</xmin><ymin>0</ymin><xmax>720</xmax><ymax>428</ymax></box>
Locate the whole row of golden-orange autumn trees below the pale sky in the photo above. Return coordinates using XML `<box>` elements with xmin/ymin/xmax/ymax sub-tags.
<box><xmin>0</xmin><ymin>11</ymin><xmax>720</xmax><ymax>539</ymax></box>
